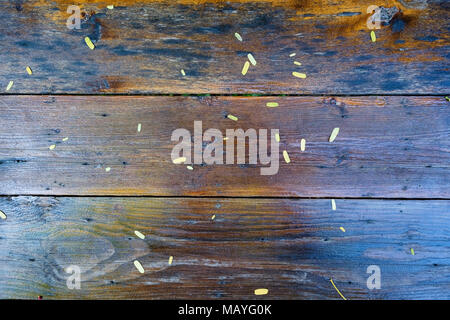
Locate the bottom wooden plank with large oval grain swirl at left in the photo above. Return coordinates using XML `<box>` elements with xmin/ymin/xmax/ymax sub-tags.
<box><xmin>0</xmin><ymin>197</ymin><xmax>450</xmax><ymax>299</ymax></box>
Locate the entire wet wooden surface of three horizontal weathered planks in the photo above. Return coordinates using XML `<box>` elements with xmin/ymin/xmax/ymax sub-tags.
<box><xmin>0</xmin><ymin>0</ymin><xmax>450</xmax><ymax>299</ymax></box>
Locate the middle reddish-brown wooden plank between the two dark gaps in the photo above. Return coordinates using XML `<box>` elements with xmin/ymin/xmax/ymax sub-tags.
<box><xmin>0</xmin><ymin>96</ymin><xmax>450</xmax><ymax>198</ymax></box>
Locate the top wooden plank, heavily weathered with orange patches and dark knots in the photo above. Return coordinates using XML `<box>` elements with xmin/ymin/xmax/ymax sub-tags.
<box><xmin>0</xmin><ymin>0</ymin><xmax>450</xmax><ymax>94</ymax></box>
